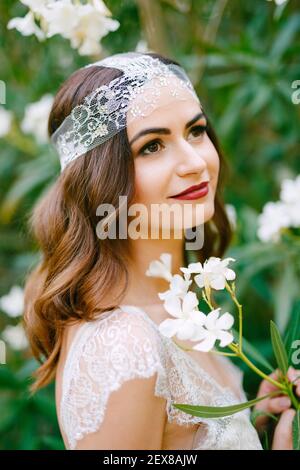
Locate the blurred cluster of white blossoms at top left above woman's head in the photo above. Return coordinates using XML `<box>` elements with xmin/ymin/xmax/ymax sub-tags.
<box><xmin>7</xmin><ymin>0</ymin><xmax>120</xmax><ymax>55</ymax></box>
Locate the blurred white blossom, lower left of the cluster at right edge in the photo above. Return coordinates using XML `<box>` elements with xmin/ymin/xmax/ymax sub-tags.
<box><xmin>257</xmin><ymin>201</ymin><xmax>290</xmax><ymax>242</ymax></box>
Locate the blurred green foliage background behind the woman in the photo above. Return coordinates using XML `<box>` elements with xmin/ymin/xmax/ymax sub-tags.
<box><xmin>0</xmin><ymin>0</ymin><xmax>300</xmax><ymax>449</ymax></box>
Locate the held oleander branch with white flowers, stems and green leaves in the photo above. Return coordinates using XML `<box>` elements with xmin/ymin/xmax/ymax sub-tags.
<box><xmin>146</xmin><ymin>253</ymin><xmax>300</xmax><ymax>442</ymax></box>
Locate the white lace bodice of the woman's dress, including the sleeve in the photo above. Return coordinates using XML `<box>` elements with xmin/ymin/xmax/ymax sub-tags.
<box><xmin>60</xmin><ymin>305</ymin><xmax>262</xmax><ymax>450</ymax></box>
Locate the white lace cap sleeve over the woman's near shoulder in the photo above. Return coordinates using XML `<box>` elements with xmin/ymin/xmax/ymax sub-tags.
<box><xmin>60</xmin><ymin>309</ymin><xmax>162</xmax><ymax>449</ymax></box>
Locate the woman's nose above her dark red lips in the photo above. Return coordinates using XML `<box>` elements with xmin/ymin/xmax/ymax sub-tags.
<box><xmin>176</xmin><ymin>141</ymin><xmax>207</xmax><ymax>175</ymax></box>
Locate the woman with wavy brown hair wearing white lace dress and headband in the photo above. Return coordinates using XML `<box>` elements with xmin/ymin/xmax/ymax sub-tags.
<box><xmin>25</xmin><ymin>49</ymin><xmax>299</xmax><ymax>449</ymax></box>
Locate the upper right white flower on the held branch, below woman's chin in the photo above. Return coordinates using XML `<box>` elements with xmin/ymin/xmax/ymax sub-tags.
<box><xmin>189</xmin><ymin>256</ymin><xmax>235</xmax><ymax>290</ymax></box>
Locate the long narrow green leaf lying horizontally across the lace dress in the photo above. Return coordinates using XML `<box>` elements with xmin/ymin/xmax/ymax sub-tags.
<box><xmin>173</xmin><ymin>390</ymin><xmax>282</xmax><ymax>418</ymax></box>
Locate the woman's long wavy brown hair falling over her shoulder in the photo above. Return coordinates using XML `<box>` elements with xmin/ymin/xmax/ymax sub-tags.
<box><xmin>24</xmin><ymin>53</ymin><xmax>232</xmax><ymax>393</ymax></box>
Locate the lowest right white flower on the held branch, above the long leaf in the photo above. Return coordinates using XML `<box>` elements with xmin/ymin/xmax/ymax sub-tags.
<box><xmin>191</xmin><ymin>307</ymin><xmax>234</xmax><ymax>352</ymax></box>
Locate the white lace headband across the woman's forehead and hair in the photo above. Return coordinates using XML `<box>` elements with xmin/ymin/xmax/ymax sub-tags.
<box><xmin>51</xmin><ymin>52</ymin><xmax>199</xmax><ymax>171</ymax></box>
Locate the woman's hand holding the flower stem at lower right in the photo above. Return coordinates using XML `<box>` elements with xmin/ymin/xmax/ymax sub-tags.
<box><xmin>254</xmin><ymin>367</ymin><xmax>300</xmax><ymax>450</ymax></box>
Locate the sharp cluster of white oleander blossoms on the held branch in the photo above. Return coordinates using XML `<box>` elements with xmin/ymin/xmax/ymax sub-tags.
<box><xmin>146</xmin><ymin>253</ymin><xmax>235</xmax><ymax>351</ymax></box>
